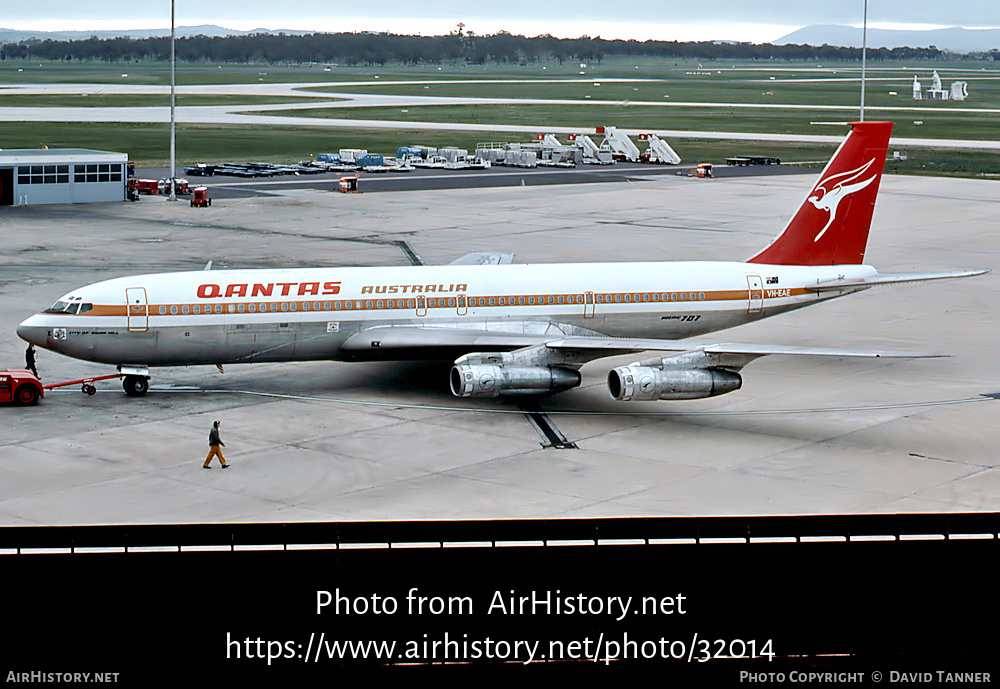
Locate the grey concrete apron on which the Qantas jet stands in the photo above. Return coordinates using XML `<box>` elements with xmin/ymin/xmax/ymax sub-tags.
<box><xmin>0</xmin><ymin>169</ymin><xmax>1000</xmax><ymax>524</ymax></box>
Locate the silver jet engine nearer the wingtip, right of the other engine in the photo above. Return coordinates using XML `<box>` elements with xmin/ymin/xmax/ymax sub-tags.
<box><xmin>608</xmin><ymin>364</ymin><xmax>743</xmax><ymax>402</ymax></box>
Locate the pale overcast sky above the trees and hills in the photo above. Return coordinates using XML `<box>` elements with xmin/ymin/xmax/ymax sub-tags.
<box><xmin>7</xmin><ymin>0</ymin><xmax>1000</xmax><ymax>42</ymax></box>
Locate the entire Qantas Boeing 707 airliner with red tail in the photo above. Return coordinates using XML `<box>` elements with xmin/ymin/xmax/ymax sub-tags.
<box><xmin>17</xmin><ymin>122</ymin><xmax>986</xmax><ymax>401</ymax></box>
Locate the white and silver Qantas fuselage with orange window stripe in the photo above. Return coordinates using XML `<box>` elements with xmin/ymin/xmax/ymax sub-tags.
<box><xmin>18</xmin><ymin>261</ymin><xmax>876</xmax><ymax>366</ymax></box>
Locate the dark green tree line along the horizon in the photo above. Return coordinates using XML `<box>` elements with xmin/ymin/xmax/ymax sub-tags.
<box><xmin>0</xmin><ymin>31</ymin><xmax>960</xmax><ymax>66</ymax></box>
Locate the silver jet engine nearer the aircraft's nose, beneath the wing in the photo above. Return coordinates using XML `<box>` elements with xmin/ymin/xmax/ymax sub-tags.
<box><xmin>450</xmin><ymin>357</ymin><xmax>581</xmax><ymax>397</ymax></box>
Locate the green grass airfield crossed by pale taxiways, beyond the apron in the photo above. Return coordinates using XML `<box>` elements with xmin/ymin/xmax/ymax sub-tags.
<box><xmin>0</xmin><ymin>59</ymin><xmax>1000</xmax><ymax>176</ymax></box>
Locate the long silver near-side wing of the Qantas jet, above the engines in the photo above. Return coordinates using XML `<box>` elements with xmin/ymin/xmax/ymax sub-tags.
<box><xmin>342</xmin><ymin>324</ymin><xmax>942</xmax><ymax>364</ymax></box>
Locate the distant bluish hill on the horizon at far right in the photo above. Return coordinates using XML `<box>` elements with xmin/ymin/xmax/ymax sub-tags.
<box><xmin>771</xmin><ymin>24</ymin><xmax>1000</xmax><ymax>53</ymax></box>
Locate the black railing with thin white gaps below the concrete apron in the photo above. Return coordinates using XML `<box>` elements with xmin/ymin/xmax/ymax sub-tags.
<box><xmin>0</xmin><ymin>512</ymin><xmax>1000</xmax><ymax>554</ymax></box>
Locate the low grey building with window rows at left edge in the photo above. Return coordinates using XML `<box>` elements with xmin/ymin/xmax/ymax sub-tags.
<box><xmin>0</xmin><ymin>148</ymin><xmax>128</xmax><ymax>206</ymax></box>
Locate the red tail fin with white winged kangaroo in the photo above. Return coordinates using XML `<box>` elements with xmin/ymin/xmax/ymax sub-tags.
<box><xmin>748</xmin><ymin>122</ymin><xmax>892</xmax><ymax>266</ymax></box>
